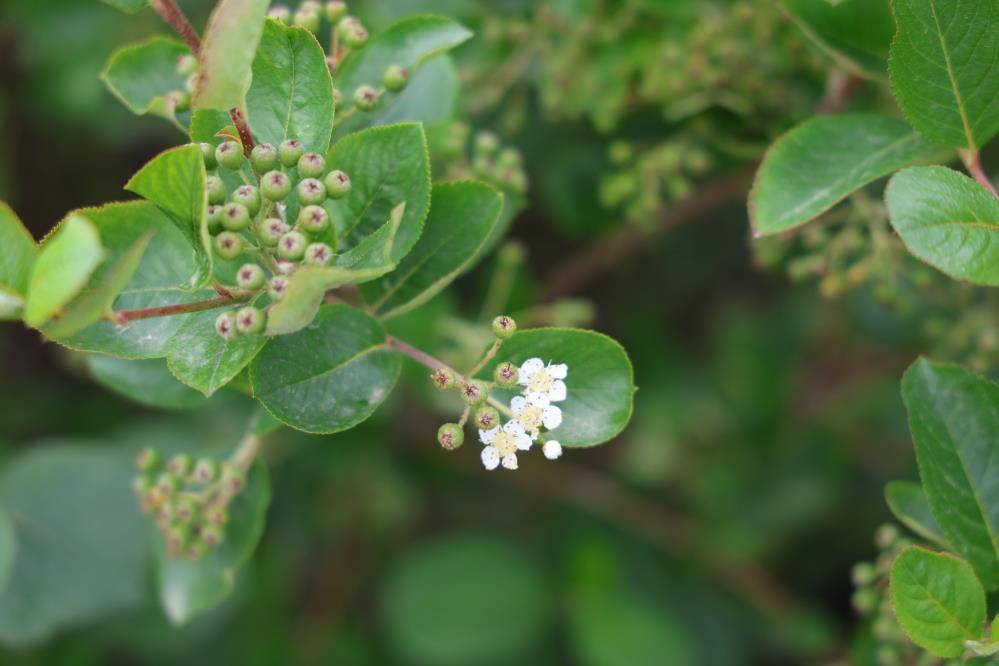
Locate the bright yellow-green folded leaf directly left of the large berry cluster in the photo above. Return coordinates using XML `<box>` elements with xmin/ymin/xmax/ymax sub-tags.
<box><xmin>125</xmin><ymin>144</ymin><xmax>212</xmax><ymax>286</ymax></box>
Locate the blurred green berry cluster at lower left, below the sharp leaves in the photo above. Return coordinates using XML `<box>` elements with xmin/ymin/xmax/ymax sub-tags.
<box><xmin>132</xmin><ymin>449</ymin><xmax>246</xmax><ymax>560</ymax></box>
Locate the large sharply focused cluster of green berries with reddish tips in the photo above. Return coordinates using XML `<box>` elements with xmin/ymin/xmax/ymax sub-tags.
<box><xmin>201</xmin><ymin>138</ymin><xmax>351</xmax><ymax>340</ymax></box>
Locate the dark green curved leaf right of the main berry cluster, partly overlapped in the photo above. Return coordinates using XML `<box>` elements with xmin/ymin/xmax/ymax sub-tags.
<box><xmin>362</xmin><ymin>181</ymin><xmax>503</xmax><ymax>319</ymax></box>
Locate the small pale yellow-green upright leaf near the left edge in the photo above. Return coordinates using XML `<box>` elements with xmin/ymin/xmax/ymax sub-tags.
<box><xmin>24</xmin><ymin>213</ymin><xmax>105</xmax><ymax>328</ymax></box>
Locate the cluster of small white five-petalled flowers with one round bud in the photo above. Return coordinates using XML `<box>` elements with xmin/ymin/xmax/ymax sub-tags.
<box><xmin>479</xmin><ymin>358</ymin><xmax>569</xmax><ymax>470</ymax></box>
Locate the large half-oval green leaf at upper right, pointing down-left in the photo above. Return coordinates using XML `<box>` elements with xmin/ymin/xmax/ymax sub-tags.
<box><xmin>749</xmin><ymin>114</ymin><xmax>939</xmax><ymax>236</ymax></box>
